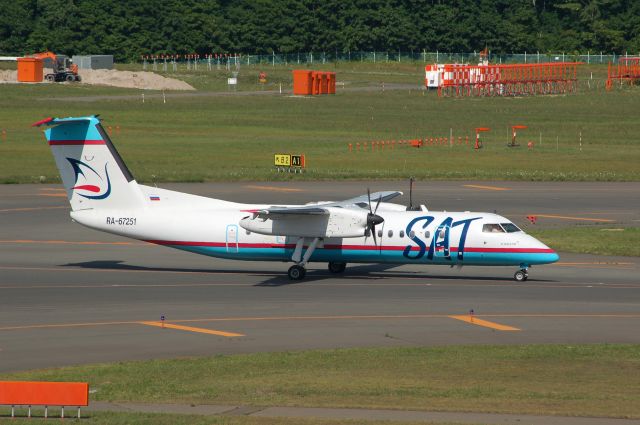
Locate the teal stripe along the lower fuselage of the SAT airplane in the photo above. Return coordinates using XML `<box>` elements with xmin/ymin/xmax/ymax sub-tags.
<box><xmin>168</xmin><ymin>245</ymin><xmax>559</xmax><ymax>266</ymax></box>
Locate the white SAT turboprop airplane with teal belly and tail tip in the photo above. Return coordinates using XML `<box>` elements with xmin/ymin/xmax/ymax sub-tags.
<box><xmin>33</xmin><ymin>116</ymin><xmax>559</xmax><ymax>281</ymax></box>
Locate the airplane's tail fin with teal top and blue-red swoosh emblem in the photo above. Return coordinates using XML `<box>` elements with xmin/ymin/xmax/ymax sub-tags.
<box><xmin>33</xmin><ymin>116</ymin><xmax>145</xmax><ymax>211</ymax></box>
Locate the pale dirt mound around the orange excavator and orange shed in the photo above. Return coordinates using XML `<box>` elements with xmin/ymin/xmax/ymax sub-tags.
<box><xmin>0</xmin><ymin>69</ymin><xmax>195</xmax><ymax>90</ymax></box>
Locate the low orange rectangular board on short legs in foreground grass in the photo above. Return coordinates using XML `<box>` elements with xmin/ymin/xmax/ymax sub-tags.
<box><xmin>0</xmin><ymin>381</ymin><xmax>89</xmax><ymax>418</ymax></box>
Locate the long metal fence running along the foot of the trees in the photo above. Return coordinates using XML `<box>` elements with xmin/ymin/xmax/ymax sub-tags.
<box><xmin>143</xmin><ymin>50</ymin><xmax>640</xmax><ymax>70</ymax></box>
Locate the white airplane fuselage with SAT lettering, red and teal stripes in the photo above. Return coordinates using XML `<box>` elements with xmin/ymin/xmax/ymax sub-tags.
<box><xmin>71</xmin><ymin>185</ymin><xmax>558</xmax><ymax>266</ymax></box>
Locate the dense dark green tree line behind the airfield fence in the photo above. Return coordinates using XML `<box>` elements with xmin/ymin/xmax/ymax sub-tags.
<box><xmin>0</xmin><ymin>0</ymin><xmax>640</xmax><ymax>62</ymax></box>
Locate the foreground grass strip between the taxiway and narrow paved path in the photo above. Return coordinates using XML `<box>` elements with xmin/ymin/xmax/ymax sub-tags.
<box><xmin>2</xmin><ymin>345</ymin><xmax>640</xmax><ymax>418</ymax></box>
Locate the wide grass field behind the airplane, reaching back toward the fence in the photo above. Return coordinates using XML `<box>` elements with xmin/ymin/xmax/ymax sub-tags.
<box><xmin>0</xmin><ymin>63</ymin><xmax>640</xmax><ymax>183</ymax></box>
